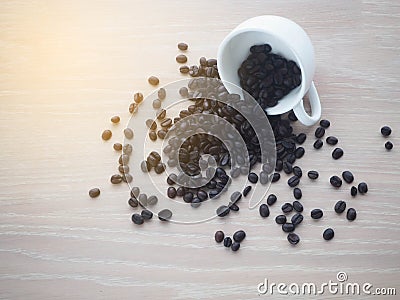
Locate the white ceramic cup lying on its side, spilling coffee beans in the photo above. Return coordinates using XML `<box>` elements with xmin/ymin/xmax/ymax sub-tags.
<box><xmin>217</xmin><ymin>15</ymin><xmax>321</xmax><ymax>126</ymax></box>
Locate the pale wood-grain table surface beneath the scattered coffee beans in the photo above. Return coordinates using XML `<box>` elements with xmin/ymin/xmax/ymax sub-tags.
<box><xmin>0</xmin><ymin>0</ymin><xmax>400</xmax><ymax>299</ymax></box>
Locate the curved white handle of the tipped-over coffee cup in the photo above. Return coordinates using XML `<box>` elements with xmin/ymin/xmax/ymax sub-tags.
<box><xmin>293</xmin><ymin>81</ymin><xmax>321</xmax><ymax>126</ymax></box>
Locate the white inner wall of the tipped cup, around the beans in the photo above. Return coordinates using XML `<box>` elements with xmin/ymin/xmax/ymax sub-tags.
<box><xmin>218</xmin><ymin>29</ymin><xmax>306</xmax><ymax>115</ymax></box>
